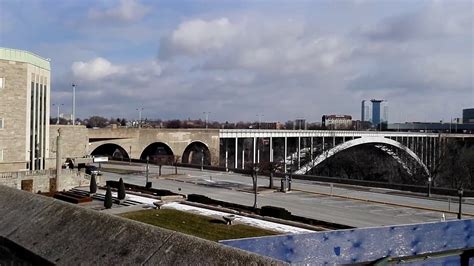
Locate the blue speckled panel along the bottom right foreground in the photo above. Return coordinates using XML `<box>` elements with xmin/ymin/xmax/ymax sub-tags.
<box><xmin>221</xmin><ymin>220</ymin><xmax>474</xmax><ymax>265</ymax></box>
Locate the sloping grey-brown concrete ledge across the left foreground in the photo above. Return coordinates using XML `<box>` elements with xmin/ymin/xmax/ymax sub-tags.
<box><xmin>0</xmin><ymin>186</ymin><xmax>284</xmax><ymax>265</ymax></box>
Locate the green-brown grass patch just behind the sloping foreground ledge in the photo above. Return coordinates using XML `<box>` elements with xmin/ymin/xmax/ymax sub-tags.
<box><xmin>120</xmin><ymin>209</ymin><xmax>278</xmax><ymax>241</ymax></box>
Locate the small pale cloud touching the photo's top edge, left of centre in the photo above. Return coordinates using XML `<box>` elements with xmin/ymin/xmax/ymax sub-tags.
<box><xmin>89</xmin><ymin>0</ymin><xmax>150</xmax><ymax>22</ymax></box>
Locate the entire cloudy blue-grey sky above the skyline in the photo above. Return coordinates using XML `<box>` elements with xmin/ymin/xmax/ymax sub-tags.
<box><xmin>0</xmin><ymin>0</ymin><xmax>474</xmax><ymax>122</ymax></box>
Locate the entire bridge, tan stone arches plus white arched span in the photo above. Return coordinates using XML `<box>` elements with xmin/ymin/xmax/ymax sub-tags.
<box><xmin>88</xmin><ymin>128</ymin><xmax>474</xmax><ymax>175</ymax></box>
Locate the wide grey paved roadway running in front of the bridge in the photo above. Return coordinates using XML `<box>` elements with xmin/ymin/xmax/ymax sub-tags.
<box><xmin>94</xmin><ymin>163</ymin><xmax>474</xmax><ymax>227</ymax></box>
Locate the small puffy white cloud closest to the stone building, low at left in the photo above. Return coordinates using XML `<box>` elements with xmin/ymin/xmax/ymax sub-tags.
<box><xmin>71</xmin><ymin>57</ymin><xmax>125</xmax><ymax>81</ymax></box>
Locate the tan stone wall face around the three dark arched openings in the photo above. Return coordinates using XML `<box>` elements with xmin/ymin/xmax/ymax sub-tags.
<box><xmin>88</xmin><ymin>128</ymin><xmax>220</xmax><ymax>165</ymax></box>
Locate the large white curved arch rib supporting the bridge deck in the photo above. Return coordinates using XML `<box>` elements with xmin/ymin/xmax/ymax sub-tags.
<box><xmin>295</xmin><ymin>137</ymin><xmax>430</xmax><ymax>176</ymax></box>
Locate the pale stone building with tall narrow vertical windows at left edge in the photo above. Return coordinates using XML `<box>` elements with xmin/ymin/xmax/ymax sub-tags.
<box><xmin>0</xmin><ymin>47</ymin><xmax>51</xmax><ymax>172</ymax></box>
